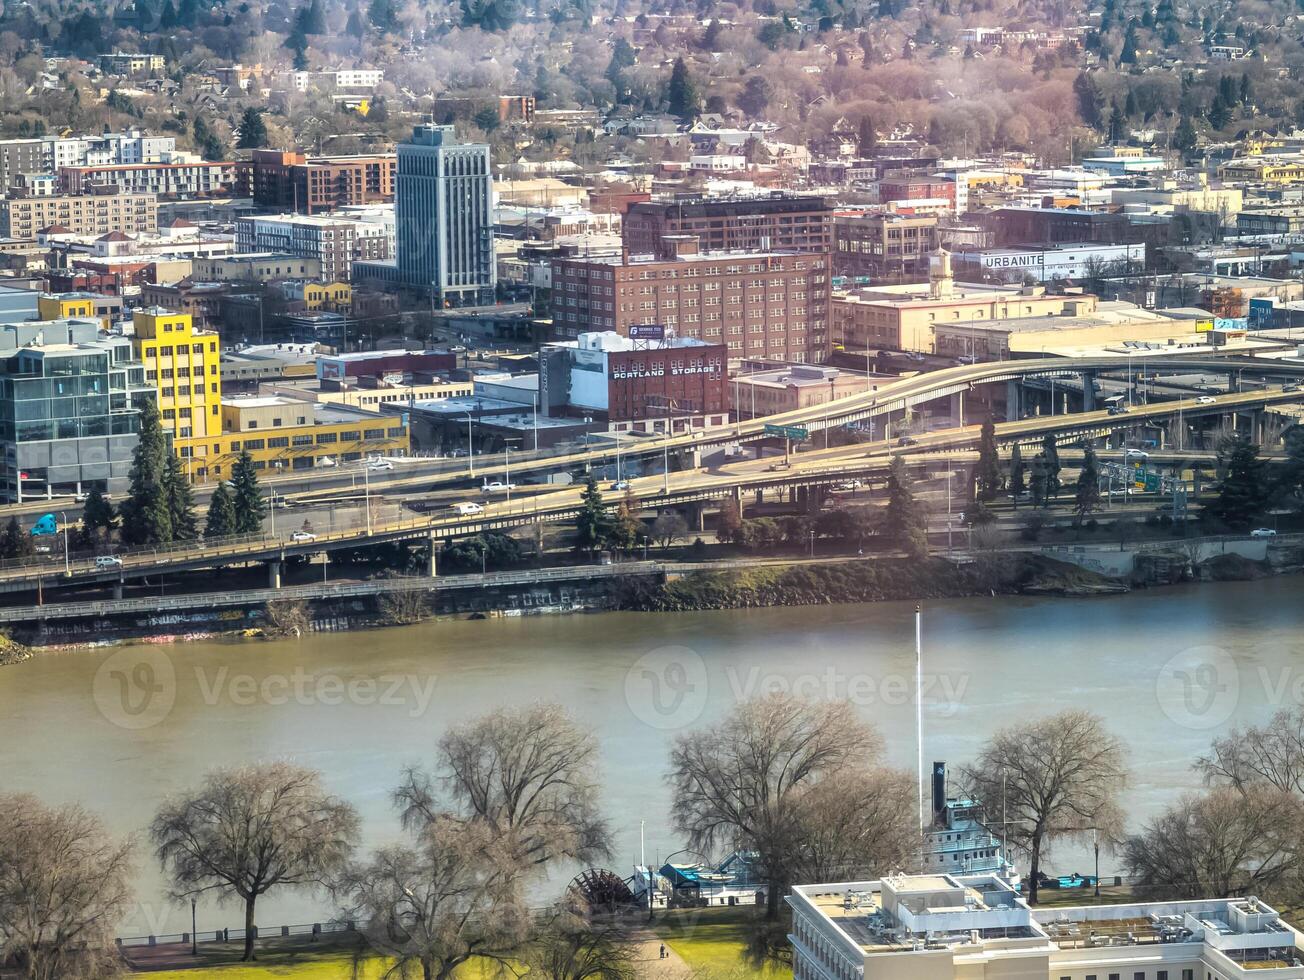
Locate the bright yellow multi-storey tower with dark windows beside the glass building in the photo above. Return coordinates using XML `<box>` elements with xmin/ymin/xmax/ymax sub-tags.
<box><xmin>132</xmin><ymin>306</ymin><xmax>222</xmax><ymax>450</ymax></box>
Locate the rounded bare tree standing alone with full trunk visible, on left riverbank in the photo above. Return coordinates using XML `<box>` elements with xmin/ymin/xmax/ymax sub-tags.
<box><xmin>150</xmin><ymin>762</ymin><xmax>359</xmax><ymax>960</ymax></box>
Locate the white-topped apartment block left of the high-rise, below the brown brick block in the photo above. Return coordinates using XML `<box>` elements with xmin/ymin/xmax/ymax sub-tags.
<box><xmin>236</xmin><ymin>214</ymin><xmax>390</xmax><ymax>281</ymax></box>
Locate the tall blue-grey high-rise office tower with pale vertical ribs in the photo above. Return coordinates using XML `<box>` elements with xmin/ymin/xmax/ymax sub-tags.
<box><xmin>353</xmin><ymin>124</ymin><xmax>497</xmax><ymax>306</ymax></box>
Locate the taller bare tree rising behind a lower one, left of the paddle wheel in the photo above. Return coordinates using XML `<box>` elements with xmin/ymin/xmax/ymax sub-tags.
<box><xmin>394</xmin><ymin>704</ymin><xmax>610</xmax><ymax>869</ymax></box>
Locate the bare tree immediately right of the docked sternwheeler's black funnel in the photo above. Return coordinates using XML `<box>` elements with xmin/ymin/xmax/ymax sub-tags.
<box><xmin>962</xmin><ymin>710</ymin><xmax>1128</xmax><ymax>903</ymax></box>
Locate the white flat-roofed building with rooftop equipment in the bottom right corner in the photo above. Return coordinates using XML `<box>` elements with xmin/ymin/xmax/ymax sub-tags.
<box><xmin>788</xmin><ymin>873</ymin><xmax>1304</xmax><ymax>980</ymax></box>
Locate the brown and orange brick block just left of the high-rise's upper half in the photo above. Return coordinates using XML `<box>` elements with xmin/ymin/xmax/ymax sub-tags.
<box><xmin>236</xmin><ymin>150</ymin><xmax>398</xmax><ymax>214</ymax></box>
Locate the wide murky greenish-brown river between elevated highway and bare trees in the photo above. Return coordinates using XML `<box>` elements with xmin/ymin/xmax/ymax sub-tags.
<box><xmin>0</xmin><ymin>577</ymin><xmax>1304</xmax><ymax>934</ymax></box>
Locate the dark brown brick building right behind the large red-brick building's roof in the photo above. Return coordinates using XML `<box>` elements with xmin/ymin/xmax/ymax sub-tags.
<box><xmin>623</xmin><ymin>193</ymin><xmax>833</xmax><ymax>255</ymax></box>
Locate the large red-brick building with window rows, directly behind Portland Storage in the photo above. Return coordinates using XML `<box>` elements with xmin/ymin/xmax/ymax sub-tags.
<box><xmin>553</xmin><ymin>235</ymin><xmax>829</xmax><ymax>361</ymax></box>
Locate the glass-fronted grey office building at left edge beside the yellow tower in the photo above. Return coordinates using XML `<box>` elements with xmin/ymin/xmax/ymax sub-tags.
<box><xmin>0</xmin><ymin>319</ymin><xmax>155</xmax><ymax>503</ymax></box>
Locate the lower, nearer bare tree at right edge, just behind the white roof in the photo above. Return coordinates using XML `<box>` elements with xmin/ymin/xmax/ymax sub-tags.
<box><xmin>1123</xmin><ymin>783</ymin><xmax>1304</xmax><ymax>901</ymax></box>
